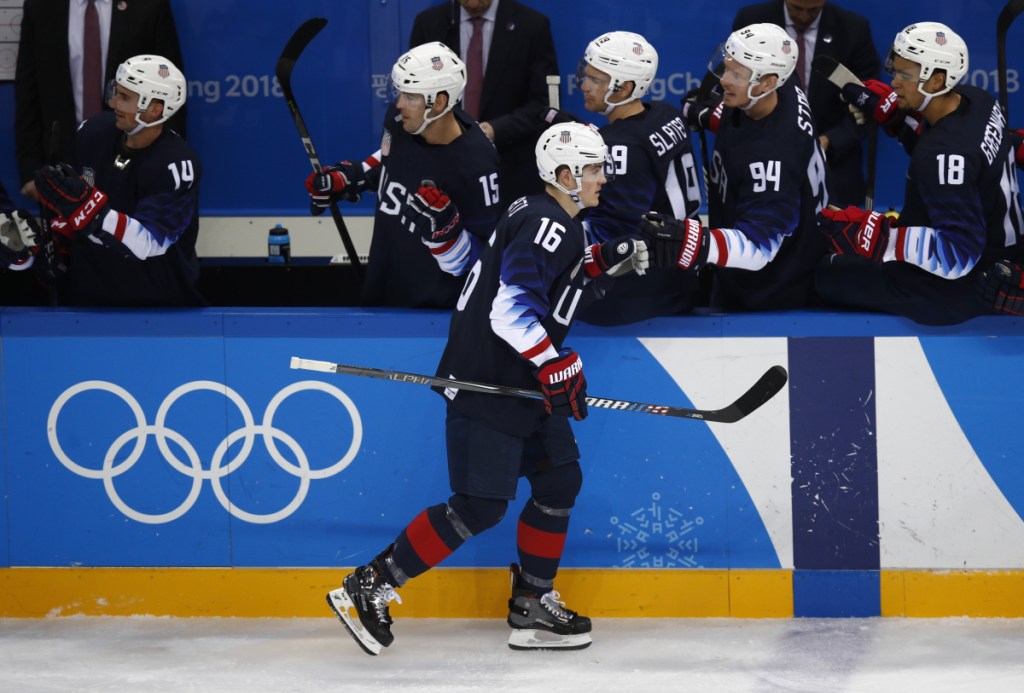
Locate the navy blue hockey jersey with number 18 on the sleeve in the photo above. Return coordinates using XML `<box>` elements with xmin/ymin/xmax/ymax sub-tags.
<box><xmin>884</xmin><ymin>85</ymin><xmax>1024</xmax><ymax>279</ymax></box>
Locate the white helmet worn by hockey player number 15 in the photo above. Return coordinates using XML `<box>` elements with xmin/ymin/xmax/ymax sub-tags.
<box><xmin>391</xmin><ymin>41</ymin><xmax>466</xmax><ymax>135</ymax></box>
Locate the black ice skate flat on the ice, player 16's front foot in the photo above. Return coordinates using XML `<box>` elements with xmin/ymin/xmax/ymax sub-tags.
<box><xmin>508</xmin><ymin>563</ymin><xmax>592</xmax><ymax>650</ymax></box>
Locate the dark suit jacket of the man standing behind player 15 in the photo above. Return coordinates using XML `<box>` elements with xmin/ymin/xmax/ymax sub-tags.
<box><xmin>409</xmin><ymin>0</ymin><xmax>558</xmax><ymax>204</ymax></box>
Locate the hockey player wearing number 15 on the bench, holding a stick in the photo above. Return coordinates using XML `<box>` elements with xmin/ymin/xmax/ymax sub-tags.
<box><xmin>306</xmin><ymin>42</ymin><xmax>504</xmax><ymax>308</ymax></box>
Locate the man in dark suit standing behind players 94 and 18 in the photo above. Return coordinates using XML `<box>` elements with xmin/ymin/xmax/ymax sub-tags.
<box><xmin>732</xmin><ymin>0</ymin><xmax>882</xmax><ymax>207</ymax></box>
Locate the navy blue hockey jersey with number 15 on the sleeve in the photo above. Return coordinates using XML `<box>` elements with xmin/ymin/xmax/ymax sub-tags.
<box><xmin>361</xmin><ymin>103</ymin><xmax>503</xmax><ymax>308</ymax></box>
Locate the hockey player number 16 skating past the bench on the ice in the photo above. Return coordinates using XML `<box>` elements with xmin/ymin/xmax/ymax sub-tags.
<box><xmin>328</xmin><ymin>123</ymin><xmax>646</xmax><ymax>654</ymax></box>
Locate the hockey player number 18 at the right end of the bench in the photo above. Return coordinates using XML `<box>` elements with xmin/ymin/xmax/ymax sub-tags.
<box><xmin>816</xmin><ymin>21</ymin><xmax>1022</xmax><ymax>324</ymax></box>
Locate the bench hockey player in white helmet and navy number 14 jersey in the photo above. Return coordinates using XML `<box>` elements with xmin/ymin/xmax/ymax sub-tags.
<box><xmin>30</xmin><ymin>55</ymin><xmax>205</xmax><ymax>306</ymax></box>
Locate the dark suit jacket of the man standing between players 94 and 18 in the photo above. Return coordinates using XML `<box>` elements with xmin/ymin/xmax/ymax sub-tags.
<box><xmin>732</xmin><ymin>0</ymin><xmax>882</xmax><ymax>207</ymax></box>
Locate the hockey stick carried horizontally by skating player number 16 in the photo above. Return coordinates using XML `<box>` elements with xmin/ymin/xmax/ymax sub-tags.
<box><xmin>292</xmin><ymin>356</ymin><xmax>790</xmax><ymax>424</ymax></box>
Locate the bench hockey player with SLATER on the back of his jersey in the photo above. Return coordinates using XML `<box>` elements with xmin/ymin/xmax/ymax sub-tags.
<box><xmin>577</xmin><ymin>32</ymin><xmax>700</xmax><ymax>324</ymax></box>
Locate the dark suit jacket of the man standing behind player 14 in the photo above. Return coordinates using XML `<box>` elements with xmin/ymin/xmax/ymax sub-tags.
<box><xmin>14</xmin><ymin>0</ymin><xmax>184</xmax><ymax>183</ymax></box>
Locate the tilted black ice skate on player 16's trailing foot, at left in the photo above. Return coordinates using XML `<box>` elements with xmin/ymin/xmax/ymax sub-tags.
<box><xmin>327</xmin><ymin>560</ymin><xmax>401</xmax><ymax>655</ymax></box>
